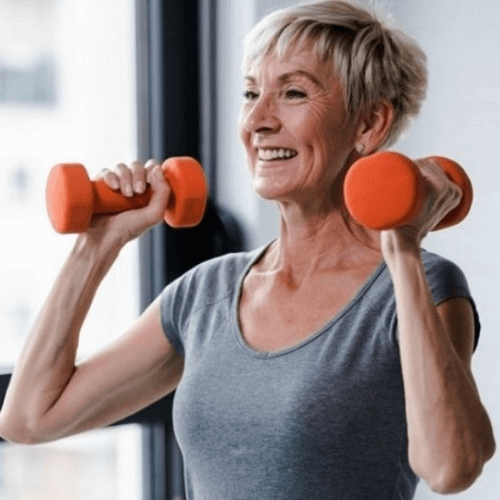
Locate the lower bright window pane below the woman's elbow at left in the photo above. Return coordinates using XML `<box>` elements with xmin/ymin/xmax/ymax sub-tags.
<box><xmin>0</xmin><ymin>425</ymin><xmax>143</xmax><ymax>500</ymax></box>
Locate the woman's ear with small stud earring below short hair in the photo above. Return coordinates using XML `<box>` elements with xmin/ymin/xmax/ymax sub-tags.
<box><xmin>355</xmin><ymin>99</ymin><xmax>394</xmax><ymax>155</ymax></box>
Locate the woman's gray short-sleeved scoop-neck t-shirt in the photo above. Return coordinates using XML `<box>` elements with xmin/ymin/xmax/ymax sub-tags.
<box><xmin>161</xmin><ymin>247</ymin><xmax>479</xmax><ymax>500</ymax></box>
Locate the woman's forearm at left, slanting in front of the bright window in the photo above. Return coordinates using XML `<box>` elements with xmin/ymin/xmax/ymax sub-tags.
<box><xmin>0</xmin><ymin>235</ymin><xmax>121</xmax><ymax>441</ymax></box>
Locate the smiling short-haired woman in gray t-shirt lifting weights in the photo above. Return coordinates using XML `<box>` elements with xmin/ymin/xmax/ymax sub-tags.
<box><xmin>0</xmin><ymin>0</ymin><xmax>495</xmax><ymax>500</ymax></box>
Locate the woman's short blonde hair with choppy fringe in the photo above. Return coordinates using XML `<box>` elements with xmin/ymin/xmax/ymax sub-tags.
<box><xmin>242</xmin><ymin>0</ymin><xmax>427</xmax><ymax>147</ymax></box>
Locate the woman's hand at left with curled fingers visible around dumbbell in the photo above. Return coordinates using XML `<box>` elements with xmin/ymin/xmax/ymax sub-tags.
<box><xmin>91</xmin><ymin>160</ymin><xmax>171</xmax><ymax>243</ymax></box>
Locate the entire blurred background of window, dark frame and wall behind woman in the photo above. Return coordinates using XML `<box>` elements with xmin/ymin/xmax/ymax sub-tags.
<box><xmin>0</xmin><ymin>0</ymin><xmax>500</xmax><ymax>500</ymax></box>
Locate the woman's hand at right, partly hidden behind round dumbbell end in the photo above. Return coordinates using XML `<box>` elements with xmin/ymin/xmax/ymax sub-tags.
<box><xmin>381</xmin><ymin>158</ymin><xmax>462</xmax><ymax>253</ymax></box>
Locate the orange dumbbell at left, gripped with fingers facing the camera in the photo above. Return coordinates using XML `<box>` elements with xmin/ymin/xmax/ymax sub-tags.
<box><xmin>46</xmin><ymin>157</ymin><xmax>208</xmax><ymax>233</ymax></box>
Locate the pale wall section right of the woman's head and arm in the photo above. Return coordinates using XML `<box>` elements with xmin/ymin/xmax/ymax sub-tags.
<box><xmin>394</xmin><ymin>0</ymin><xmax>500</xmax><ymax>500</ymax></box>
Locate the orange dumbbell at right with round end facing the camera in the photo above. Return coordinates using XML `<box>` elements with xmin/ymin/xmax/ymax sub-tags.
<box><xmin>344</xmin><ymin>152</ymin><xmax>472</xmax><ymax>230</ymax></box>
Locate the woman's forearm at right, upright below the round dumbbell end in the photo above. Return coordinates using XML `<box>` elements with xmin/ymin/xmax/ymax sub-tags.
<box><xmin>384</xmin><ymin>235</ymin><xmax>492</xmax><ymax>492</ymax></box>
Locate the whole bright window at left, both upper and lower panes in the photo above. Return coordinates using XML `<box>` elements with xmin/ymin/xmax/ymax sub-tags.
<box><xmin>0</xmin><ymin>0</ymin><xmax>142</xmax><ymax>494</ymax></box>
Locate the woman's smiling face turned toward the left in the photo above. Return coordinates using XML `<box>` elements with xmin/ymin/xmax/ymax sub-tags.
<box><xmin>239</xmin><ymin>46</ymin><xmax>360</xmax><ymax>205</ymax></box>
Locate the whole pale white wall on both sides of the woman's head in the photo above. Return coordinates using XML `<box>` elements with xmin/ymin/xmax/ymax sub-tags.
<box><xmin>218</xmin><ymin>0</ymin><xmax>500</xmax><ymax>500</ymax></box>
